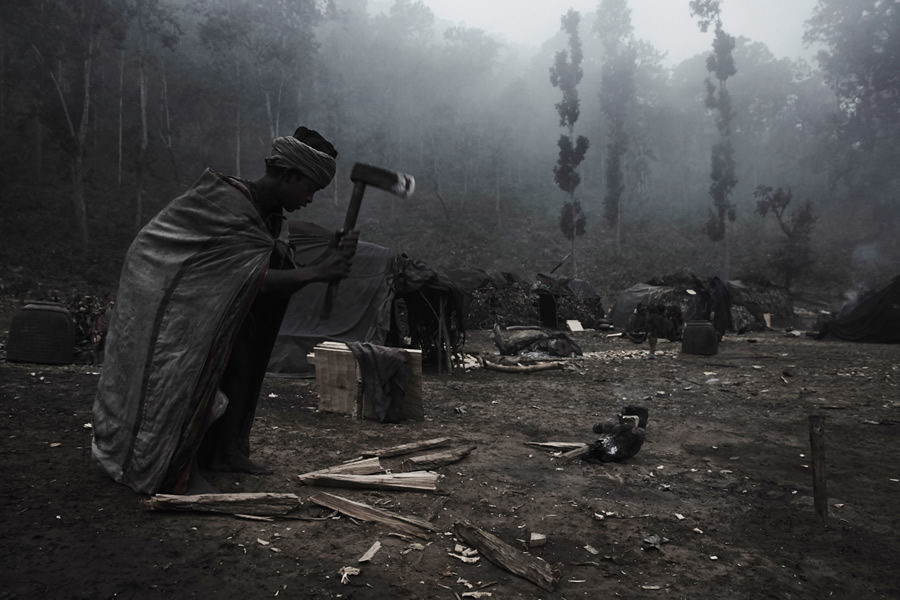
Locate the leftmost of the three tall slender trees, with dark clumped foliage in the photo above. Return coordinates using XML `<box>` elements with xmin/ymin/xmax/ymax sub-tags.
<box><xmin>550</xmin><ymin>9</ymin><xmax>590</xmax><ymax>277</ymax></box>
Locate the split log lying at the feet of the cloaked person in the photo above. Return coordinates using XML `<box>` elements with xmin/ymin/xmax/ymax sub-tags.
<box><xmin>148</xmin><ymin>492</ymin><xmax>300</xmax><ymax>517</ymax></box>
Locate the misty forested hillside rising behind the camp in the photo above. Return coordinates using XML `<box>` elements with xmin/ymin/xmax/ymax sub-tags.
<box><xmin>0</xmin><ymin>0</ymin><xmax>900</xmax><ymax>292</ymax></box>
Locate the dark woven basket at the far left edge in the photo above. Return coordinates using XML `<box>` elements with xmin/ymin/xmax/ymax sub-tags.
<box><xmin>6</xmin><ymin>302</ymin><xmax>75</xmax><ymax>365</ymax></box>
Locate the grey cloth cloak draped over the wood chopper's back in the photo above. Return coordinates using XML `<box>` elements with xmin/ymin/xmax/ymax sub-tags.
<box><xmin>92</xmin><ymin>170</ymin><xmax>278</xmax><ymax>494</ymax></box>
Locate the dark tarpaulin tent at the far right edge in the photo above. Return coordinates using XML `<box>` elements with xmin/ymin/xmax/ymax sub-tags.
<box><xmin>819</xmin><ymin>276</ymin><xmax>900</xmax><ymax>344</ymax></box>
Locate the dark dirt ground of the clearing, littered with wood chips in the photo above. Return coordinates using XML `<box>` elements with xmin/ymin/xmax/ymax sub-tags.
<box><xmin>0</xmin><ymin>331</ymin><xmax>900</xmax><ymax>600</ymax></box>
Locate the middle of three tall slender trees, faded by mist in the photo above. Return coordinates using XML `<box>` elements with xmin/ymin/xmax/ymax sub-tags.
<box><xmin>594</xmin><ymin>0</ymin><xmax>637</xmax><ymax>256</ymax></box>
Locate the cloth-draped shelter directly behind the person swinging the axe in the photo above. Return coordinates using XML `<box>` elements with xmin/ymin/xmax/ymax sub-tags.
<box><xmin>268</xmin><ymin>222</ymin><xmax>465</xmax><ymax>377</ymax></box>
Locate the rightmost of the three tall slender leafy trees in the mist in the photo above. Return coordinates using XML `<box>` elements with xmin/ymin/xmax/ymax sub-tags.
<box><xmin>690</xmin><ymin>0</ymin><xmax>737</xmax><ymax>281</ymax></box>
